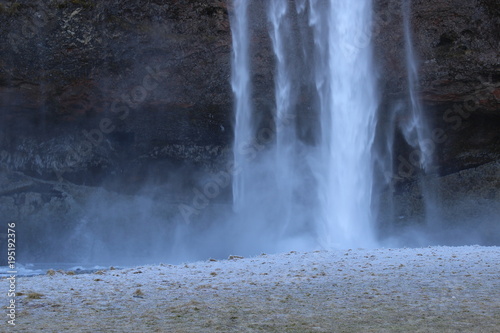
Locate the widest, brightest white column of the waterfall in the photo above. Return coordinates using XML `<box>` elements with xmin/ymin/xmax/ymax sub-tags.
<box><xmin>310</xmin><ymin>0</ymin><xmax>378</xmax><ymax>247</ymax></box>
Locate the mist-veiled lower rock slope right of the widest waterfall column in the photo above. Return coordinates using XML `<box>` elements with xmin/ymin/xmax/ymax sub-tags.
<box><xmin>378</xmin><ymin>160</ymin><xmax>500</xmax><ymax>246</ymax></box>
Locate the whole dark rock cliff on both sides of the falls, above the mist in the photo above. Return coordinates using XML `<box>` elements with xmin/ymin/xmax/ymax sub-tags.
<box><xmin>0</xmin><ymin>0</ymin><xmax>500</xmax><ymax>233</ymax></box>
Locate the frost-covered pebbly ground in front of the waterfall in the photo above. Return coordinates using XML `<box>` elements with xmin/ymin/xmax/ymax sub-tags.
<box><xmin>0</xmin><ymin>246</ymin><xmax>500</xmax><ymax>333</ymax></box>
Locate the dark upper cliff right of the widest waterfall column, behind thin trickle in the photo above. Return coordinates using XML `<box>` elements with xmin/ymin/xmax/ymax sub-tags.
<box><xmin>375</xmin><ymin>0</ymin><xmax>500</xmax><ymax>174</ymax></box>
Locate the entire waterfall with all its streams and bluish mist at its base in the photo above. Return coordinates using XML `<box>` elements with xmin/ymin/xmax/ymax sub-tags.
<box><xmin>0</xmin><ymin>0</ymin><xmax>498</xmax><ymax>275</ymax></box>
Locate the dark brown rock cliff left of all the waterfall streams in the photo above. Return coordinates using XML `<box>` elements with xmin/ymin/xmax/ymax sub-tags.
<box><xmin>0</xmin><ymin>1</ymin><xmax>232</xmax><ymax>188</ymax></box>
